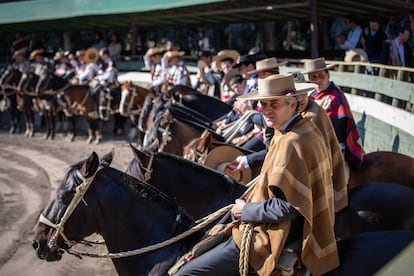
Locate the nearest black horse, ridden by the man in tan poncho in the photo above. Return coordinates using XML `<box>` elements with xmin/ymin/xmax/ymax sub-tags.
<box><xmin>32</xmin><ymin>153</ymin><xmax>414</xmax><ymax>275</ymax></box>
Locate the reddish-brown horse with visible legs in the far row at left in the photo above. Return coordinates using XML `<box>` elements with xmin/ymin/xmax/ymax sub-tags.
<box><xmin>58</xmin><ymin>85</ymin><xmax>102</xmax><ymax>144</ymax></box>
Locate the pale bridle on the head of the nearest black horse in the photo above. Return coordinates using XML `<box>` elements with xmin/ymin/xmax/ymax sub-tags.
<box><xmin>38</xmin><ymin>167</ymin><xmax>103</xmax><ymax>252</ymax></box>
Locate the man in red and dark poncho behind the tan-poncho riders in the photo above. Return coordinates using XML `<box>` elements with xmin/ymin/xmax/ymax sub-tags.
<box><xmin>303</xmin><ymin>58</ymin><xmax>364</xmax><ymax>169</ymax></box>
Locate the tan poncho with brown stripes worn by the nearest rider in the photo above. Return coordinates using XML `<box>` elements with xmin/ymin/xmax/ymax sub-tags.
<box><xmin>232</xmin><ymin>119</ymin><xmax>339</xmax><ymax>276</ymax></box>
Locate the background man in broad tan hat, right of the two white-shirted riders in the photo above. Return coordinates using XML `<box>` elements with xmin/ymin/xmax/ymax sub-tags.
<box><xmin>213</xmin><ymin>49</ymin><xmax>240</xmax><ymax>102</ymax></box>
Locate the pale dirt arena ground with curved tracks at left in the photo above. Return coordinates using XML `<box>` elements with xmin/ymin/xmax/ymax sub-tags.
<box><xmin>0</xmin><ymin>130</ymin><xmax>139</xmax><ymax>276</ymax></box>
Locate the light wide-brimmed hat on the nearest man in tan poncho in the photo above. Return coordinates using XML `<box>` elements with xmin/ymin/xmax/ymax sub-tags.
<box><xmin>237</xmin><ymin>74</ymin><xmax>316</xmax><ymax>100</ymax></box>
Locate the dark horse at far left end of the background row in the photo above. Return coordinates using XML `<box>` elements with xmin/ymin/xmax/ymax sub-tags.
<box><xmin>1</xmin><ymin>67</ymin><xmax>23</xmax><ymax>134</ymax></box>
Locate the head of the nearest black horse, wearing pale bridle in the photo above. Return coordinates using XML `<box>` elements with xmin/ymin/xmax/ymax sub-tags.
<box><xmin>32</xmin><ymin>151</ymin><xmax>113</xmax><ymax>261</ymax></box>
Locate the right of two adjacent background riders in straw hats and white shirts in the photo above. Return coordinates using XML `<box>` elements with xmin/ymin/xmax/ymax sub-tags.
<box><xmin>164</xmin><ymin>50</ymin><xmax>191</xmax><ymax>87</ymax></box>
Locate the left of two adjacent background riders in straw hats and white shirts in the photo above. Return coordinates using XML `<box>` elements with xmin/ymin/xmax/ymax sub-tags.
<box><xmin>144</xmin><ymin>47</ymin><xmax>167</xmax><ymax>92</ymax></box>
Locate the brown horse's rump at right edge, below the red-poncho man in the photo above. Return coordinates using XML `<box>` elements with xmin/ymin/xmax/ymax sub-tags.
<box><xmin>348</xmin><ymin>151</ymin><xmax>414</xmax><ymax>189</ymax></box>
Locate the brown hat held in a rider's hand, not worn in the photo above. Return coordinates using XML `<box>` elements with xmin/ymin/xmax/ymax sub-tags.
<box><xmin>204</xmin><ymin>145</ymin><xmax>252</xmax><ymax>184</ymax></box>
